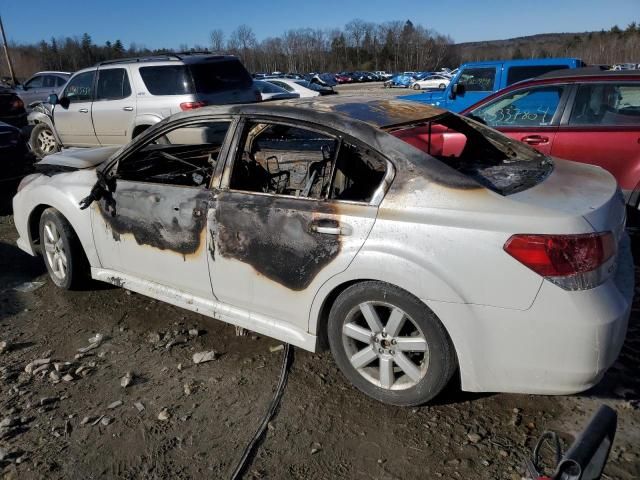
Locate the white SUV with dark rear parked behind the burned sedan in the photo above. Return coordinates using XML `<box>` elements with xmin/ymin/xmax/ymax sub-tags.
<box><xmin>29</xmin><ymin>54</ymin><xmax>260</xmax><ymax>157</ymax></box>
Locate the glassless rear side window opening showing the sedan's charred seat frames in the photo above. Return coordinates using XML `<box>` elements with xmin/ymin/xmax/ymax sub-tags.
<box><xmin>230</xmin><ymin>123</ymin><xmax>386</xmax><ymax>202</ymax></box>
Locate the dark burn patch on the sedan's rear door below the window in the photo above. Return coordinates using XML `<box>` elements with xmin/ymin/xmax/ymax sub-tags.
<box><xmin>215</xmin><ymin>192</ymin><xmax>341</xmax><ymax>291</ymax></box>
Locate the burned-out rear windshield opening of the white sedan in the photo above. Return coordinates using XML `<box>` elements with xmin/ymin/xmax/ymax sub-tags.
<box><xmin>386</xmin><ymin>113</ymin><xmax>553</xmax><ymax>195</ymax></box>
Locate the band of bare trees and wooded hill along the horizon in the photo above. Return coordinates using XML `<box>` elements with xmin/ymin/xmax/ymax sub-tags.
<box><xmin>0</xmin><ymin>19</ymin><xmax>640</xmax><ymax>80</ymax></box>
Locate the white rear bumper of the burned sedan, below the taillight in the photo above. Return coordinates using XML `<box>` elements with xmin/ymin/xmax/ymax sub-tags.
<box><xmin>427</xmin><ymin>232</ymin><xmax>634</xmax><ymax>394</ymax></box>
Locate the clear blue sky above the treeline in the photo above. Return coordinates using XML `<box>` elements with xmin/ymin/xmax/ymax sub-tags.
<box><xmin>0</xmin><ymin>0</ymin><xmax>640</xmax><ymax>48</ymax></box>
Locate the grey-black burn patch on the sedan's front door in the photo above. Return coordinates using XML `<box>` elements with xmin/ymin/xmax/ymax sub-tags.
<box><xmin>98</xmin><ymin>182</ymin><xmax>211</xmax><ymax>257</ymax></box>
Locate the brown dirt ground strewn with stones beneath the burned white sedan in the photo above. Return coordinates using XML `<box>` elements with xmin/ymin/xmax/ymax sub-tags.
<box><xmin>0</xmin><ymin>109</ymin><xmax>640</xmax><ymax>480</ymax></box>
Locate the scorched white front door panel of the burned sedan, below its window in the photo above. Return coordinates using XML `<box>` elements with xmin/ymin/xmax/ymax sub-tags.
<box><xmin>92</xmin><ymin>180</ymin><xmax>212</xmax><ymax>298</ymax></box>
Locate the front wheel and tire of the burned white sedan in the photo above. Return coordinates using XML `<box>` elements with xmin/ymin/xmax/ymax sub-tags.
<box><xmin>39</xmin><ymin>208</ymin><xmax>89</xmax><ymax>290</ymax></box>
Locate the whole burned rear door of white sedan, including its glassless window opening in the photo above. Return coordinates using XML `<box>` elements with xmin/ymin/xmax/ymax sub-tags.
<box><xmin>209</xmin><ymin>121</ymin><xmax>387</xmax><ymax>331</ymax></box>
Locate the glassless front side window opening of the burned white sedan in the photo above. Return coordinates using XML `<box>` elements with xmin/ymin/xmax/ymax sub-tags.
<box><xmin>117</xmin><ymin>122</ymin><xmax>229</xmax><ymax>187</ymax></box>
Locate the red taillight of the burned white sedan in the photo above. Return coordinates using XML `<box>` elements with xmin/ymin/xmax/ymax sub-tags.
<box><xmin>504</xmin><ymin>232</ymin><xmax>616</xmax><ymax>277</ymax></box>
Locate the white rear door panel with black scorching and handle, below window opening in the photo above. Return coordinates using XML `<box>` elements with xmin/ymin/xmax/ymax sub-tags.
<box><xmin>208</xmin><ymin>191</ymin><xmax>377</xmax><ymax>330</ymax></box>
